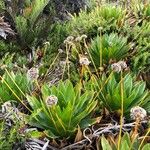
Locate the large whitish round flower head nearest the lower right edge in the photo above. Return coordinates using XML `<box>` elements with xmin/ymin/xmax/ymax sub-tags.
<box><xmin>130</xmin><ymin>106</ymin><xmax>147</xmax><ymax>120</ymax></box>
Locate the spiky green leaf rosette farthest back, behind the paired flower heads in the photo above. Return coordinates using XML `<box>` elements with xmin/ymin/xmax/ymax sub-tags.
<box><xmin>89</xmin><ymin>33</ymin><xmax>129</xmax><ymax>67</ymax></box>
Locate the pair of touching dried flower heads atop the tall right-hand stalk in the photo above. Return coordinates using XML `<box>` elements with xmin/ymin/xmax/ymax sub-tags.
<box><xmin>111</xmin><ymin>61</ymin><xmax>127</xmax><ymax>73</ymax></box>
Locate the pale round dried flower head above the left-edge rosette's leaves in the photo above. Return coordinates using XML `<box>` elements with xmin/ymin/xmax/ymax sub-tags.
<box><xmin>27</xmin><ymin>68</ymin><xmax>39</xmax><ymax>80</ymax></box>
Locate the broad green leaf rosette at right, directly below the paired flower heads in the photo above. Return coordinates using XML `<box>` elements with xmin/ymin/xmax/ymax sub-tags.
<box><xmin>87</xmin><ymin>74</ymin><xmax>149</xmax><ymax>116</ymax></box>
